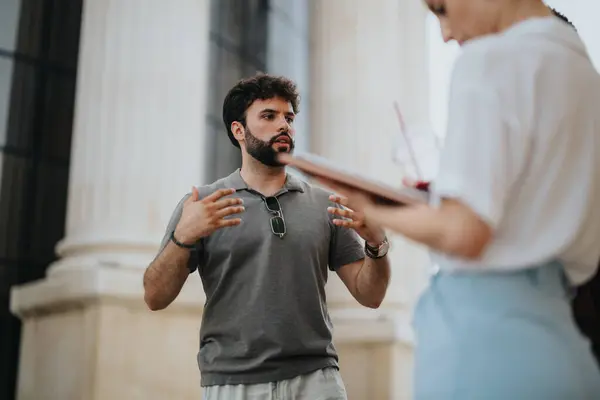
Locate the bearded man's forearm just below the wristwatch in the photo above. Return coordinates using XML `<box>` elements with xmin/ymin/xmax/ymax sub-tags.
<box><xmin>356</xmin><ymin>256</ymin><xmax>391</xmax><ymax>308</ymax></box>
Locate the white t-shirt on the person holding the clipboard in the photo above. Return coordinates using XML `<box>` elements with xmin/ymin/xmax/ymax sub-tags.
<box><xmin>432</xmin><ymin>17</ymin><xmax>600</xmax><ymax>284</ymax></box>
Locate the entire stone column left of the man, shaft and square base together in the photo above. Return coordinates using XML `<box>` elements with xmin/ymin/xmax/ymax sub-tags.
<box><xmin>11</xmin><ymin>0</ymin><xmax>210</xmax><ymax>400</ymax></box>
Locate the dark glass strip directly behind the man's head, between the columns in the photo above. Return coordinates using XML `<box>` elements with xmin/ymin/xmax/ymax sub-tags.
<box><xmin>205</xmin><ymin>0</ymin><xmax>269</xmax><ymax>181</ymax></box>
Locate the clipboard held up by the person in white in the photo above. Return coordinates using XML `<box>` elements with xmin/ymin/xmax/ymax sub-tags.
<box><xmin>277</xmin><ymin>153</ymin><xmax>429</xmax><ymax>206</ymax></box>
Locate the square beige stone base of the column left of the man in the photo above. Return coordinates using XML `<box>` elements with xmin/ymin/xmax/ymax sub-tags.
<box><xmin>11</xmin><ymin>268</ymin><xmax>204</xmax><ymax>400</ymax></box>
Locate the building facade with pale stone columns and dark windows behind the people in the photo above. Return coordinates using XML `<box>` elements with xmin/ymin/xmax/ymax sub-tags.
<box><xmin>0</xmin><ymin>0</ymin><xmax>596</xmax><ymax>400</ymax></box>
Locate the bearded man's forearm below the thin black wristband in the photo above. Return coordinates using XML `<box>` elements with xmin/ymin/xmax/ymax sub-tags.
<box><xmin>144</xmin><ymin>242</ymin><xmax>190</xmax><ymax>310</ymax></box>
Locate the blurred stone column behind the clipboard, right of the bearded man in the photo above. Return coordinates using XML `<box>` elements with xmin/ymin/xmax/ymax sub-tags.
<box><xmin>311</xmin><ymin>0</ymin><xmax>428</xmax><ymax>399</ymax></box>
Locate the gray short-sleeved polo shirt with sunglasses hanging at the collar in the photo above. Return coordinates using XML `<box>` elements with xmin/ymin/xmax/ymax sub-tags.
<box><xmin>163</xmin><ymin>170</ymin><xmax>364</xmax><ymax>386</ymax></box>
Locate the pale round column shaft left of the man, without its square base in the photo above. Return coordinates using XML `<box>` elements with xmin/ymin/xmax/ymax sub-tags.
<box><xmin>51</xmin><ymin>0</ymin><xmax>208</xmax><ymax>273</ymax></box>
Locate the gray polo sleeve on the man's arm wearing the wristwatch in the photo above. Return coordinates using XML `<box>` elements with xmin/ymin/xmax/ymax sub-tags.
<box><xmin>329</xmin><ymin>203</ymin><xmax>365</xmax><ymax>271</ymax></box>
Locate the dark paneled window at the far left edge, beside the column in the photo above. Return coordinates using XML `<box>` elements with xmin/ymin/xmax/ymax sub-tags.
<box><xmin>0</xmin><ymin>0</ymin><xmax>82</xmax><ymax>399</ymax></box>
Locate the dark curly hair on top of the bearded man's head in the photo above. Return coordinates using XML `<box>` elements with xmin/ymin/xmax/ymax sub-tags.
<box><xmin>223</xmin><ymin>73</ymin><xmax>300</xmax><ymax>148</ymax></box>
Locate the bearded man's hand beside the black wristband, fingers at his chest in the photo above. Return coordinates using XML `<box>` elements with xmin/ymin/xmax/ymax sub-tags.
<box><xmin>175</xmin><ymin>187</ymin><xmax>244</xmax><ymax>244</ymax></box>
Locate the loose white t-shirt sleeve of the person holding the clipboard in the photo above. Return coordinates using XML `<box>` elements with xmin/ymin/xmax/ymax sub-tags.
<box><xmin>434</xmin><ymin>47</ymin><xmax>527</xmax><ymax>229</ymax></box>
